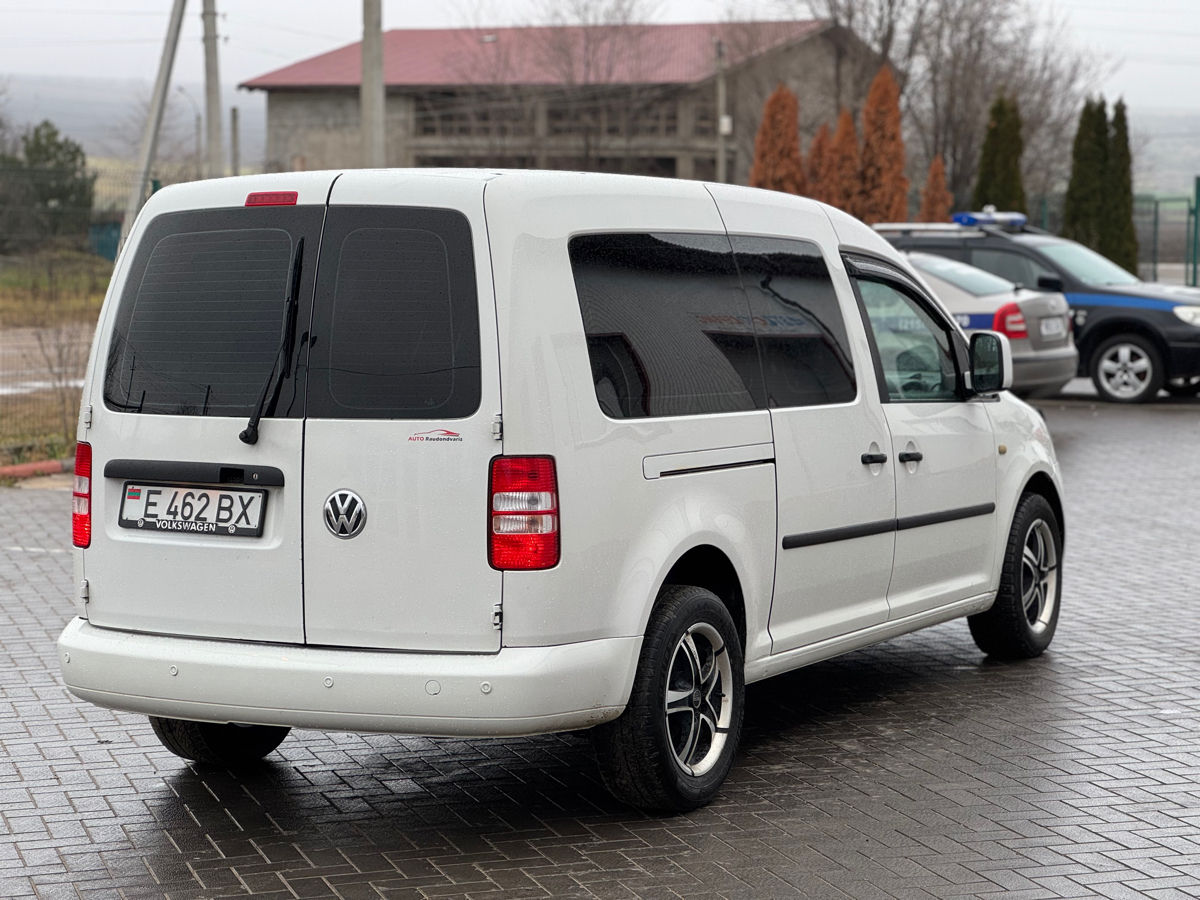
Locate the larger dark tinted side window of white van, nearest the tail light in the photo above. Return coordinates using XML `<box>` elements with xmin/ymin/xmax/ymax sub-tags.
<box><xmin>569</xmin><ymin>234</ymin><xmax>762</xmax><ymax>419</ymax></box>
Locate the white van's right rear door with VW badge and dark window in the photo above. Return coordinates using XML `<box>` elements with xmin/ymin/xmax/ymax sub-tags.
<box><xmin>304</xmin><ymin>172</ymin><xmax>502</xmax><ymax>653</ymax></box>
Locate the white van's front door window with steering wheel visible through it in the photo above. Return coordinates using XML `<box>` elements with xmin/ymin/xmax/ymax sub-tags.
<box><xmin>856</xmin><ymin>277</ymin><xmax>958</xmax><ymax>402</ymax></box>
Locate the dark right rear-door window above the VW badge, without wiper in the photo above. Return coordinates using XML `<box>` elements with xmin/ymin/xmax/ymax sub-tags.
<box><xmin>308</xmin><ymin>206</ymin><xmax>480</xmax><ymax>419</ymax></box>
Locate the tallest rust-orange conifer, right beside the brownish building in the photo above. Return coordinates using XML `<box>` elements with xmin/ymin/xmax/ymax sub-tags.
<box><xmin>859</xmin><ymin>66</ymin><xmax>908</xmax><ymax>224</ymax></box>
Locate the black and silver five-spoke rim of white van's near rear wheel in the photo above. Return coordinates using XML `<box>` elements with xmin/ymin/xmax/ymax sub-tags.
<box><xmin>664</xmin><ymin>622</ymin><xmax>733</xmax><ymax>775</ymax></box>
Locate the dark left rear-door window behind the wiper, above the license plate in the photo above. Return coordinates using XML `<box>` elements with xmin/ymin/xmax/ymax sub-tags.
<box><xmin>104</xmin><ymin>206</ymin><xmax>323</xmax><ymax>416</ymax></box>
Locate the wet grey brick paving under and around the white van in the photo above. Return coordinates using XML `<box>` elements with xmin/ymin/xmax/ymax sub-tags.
<box><xmin>0</xmin><ymin>400</ymin><xmax>1200</xmax><ymax>898</ymax></box>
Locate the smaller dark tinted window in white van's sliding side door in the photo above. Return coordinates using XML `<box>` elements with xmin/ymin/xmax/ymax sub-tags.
<box><xmin>732</xmin><ymin>236</ymin><xmax>856</xmax><ymax>407</ymax></box>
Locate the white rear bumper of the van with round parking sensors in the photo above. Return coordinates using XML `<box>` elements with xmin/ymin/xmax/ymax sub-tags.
<box><xmin>59</xmin><ymin>618</ymin><xmax>642</xmax><ymax>737</ymax></box>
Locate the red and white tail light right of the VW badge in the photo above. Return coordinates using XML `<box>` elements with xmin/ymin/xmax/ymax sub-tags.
<box><xmin>487</xmin><ymin>456</ymin><xmax>558</xmax><ymax>570</ymax></box>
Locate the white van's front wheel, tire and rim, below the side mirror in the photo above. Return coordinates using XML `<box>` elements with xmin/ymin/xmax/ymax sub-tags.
<box><xmin>967</xmin><ymin>493</ymin><xmax>1062</xmax><ymax>659</ymax></box>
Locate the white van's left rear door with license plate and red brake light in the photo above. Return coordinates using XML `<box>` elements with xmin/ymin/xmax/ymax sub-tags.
<box><xmin>82</xmin><ymin>173</ymin><xmax>334</xmax><ymax>643</ymax></box>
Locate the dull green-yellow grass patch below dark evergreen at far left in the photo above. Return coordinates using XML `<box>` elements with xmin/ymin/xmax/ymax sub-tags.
<box><xmin>0</xmin><ymin>248</ymin><xmax>113</xmax><ymax>328</ymax></box>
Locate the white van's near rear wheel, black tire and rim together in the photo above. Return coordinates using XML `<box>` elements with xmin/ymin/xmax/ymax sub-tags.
<box><xmin>592</xmin><ymin>586</ymin><xmax>745</xmax><ymax>812</ymax></box>
